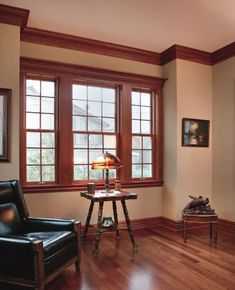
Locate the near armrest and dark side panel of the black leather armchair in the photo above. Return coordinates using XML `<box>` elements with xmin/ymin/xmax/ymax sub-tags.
<box><xmin>0</xmin><ymin>235</ymin><xmax>42</xmax><ymax>280</ymax></box>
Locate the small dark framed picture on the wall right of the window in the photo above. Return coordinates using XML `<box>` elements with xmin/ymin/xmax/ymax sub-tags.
<box><xmin>182</xmin><ymin>118</ymin><xmax>210</xmax><ymax>147</ymax></box>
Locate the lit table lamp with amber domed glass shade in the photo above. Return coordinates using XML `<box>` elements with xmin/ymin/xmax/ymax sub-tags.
<box><xmin>91</xmin><ymin>152</ymin><xmax>122</xmax><ymax>192</ymax></box>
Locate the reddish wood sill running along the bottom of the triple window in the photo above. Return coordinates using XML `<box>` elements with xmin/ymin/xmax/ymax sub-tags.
<box><xmin>22</xmin><ymin>180</ymin><xmax>163</xmax><ymax>194</ymax></box>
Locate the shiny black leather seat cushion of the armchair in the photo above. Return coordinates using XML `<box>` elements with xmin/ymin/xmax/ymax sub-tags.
<box><xmin>25</xmin><ymin>231</ymin><xmax>76</xmax><ymax>260</ymax></box>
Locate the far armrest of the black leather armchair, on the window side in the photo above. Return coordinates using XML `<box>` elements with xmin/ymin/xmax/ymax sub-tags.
<box><xmin>24</xmin><ymin>217</ymin><xmax>80</xmax><ymax>232</ymax></box>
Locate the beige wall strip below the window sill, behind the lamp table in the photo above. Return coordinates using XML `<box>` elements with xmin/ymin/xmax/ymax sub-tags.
<box><xmin>25</xmin><ymin>187</ymin><xmax>162</xmax><ymax>224</ymax></box>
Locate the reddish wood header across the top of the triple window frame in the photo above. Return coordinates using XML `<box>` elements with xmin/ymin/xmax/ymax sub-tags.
<box><xmin>20</xmin><ymin>57</ymin><xmax>166</xmax><ymax>88</ymax></box>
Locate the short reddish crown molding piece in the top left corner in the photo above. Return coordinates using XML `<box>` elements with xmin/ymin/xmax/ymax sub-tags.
<box><xmin>0</xmin><ymin>4</ymin><xmax>29</xmax><ymax>31</ymax></box>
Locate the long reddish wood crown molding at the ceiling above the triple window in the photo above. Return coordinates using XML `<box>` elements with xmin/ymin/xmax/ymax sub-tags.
<box><xmin>21</xmin><ymin>27</ymin><xmax>160</xmax><ymax>65</ymax></box>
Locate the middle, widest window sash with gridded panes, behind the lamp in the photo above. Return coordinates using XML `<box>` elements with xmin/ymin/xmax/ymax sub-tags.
<box><xmin>72</xmin><ymin>84</ymin><xmax>117</xmax><ymax>180</ymax></box>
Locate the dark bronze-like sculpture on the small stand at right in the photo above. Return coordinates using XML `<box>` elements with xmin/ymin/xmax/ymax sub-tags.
<box><xmin>183</xmin><ymin>195</ymin><xmax>216</xmax><ymax>215</ymax></box>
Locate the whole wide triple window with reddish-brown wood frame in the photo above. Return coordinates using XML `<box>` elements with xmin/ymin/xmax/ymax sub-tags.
<box><xmin>20</xmin><ymin>58</ymin><xmax>164</xmax><ymax>192</ymax></box>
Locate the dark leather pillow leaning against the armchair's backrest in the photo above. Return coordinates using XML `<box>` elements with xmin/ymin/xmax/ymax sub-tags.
<box><xmin>0</xmin><ymin>202</ymin><xmax>22</xmax><ymax>235</ymax></box>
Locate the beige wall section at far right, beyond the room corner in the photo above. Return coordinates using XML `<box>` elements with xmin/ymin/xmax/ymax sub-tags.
<box><xmin>213</xmin><ymin>57</ymin><xmax>235</xmax><ymax>221</ymax></box>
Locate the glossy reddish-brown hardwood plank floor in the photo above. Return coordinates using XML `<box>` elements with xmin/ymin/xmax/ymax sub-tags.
<box><xmin>0</xmin><ymin>228</ymin><xmax>235</xmax><ymax>290</ymax></box>
